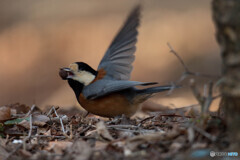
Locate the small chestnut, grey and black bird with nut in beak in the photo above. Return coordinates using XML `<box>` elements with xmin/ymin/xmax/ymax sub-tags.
<box><xmin>59</xmin><ymin>5</ymin><xmax>172</xmax><ymax>118</ymax></box>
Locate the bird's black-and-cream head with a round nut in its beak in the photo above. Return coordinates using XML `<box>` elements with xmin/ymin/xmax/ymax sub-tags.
<box><xmin>59</xmin><ymin>62</ymin><xmax>97</xmax><ymax>86</ymax></box>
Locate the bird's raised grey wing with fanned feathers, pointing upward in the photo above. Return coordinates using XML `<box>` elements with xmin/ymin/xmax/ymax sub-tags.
<box><xmin>98</xmin><ymin>5</ymin><xmax>140</xmax><ymax>80</ymax></box>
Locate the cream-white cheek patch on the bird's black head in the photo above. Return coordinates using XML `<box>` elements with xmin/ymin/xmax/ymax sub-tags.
<box><xmin>72</xmin><ymin>71</ymin><xmax>95</xmax><ymax>86</ymax></box>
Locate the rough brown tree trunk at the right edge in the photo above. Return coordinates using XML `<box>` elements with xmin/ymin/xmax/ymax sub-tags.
<box><xmin>212</xmin><ymin>0</ymin><xmax>240</xmax><ymax>142</ymax></box>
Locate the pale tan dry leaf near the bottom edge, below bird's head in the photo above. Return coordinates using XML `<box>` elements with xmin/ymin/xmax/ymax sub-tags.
<box><xmin>45</xmin><ymin>141</ymin><xmax>73</xmax><ymax>154</ymax></box>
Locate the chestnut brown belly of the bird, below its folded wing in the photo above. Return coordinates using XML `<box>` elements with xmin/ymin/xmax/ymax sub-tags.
<box><xmin>79</xmin><ymin>93</ymin><xmax>138</xmax><ymax>117</ymax></box>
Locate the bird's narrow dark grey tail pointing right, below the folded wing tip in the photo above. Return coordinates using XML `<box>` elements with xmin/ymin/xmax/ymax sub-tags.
<box><xmin>134</xmin><ymin>85</ymin><xmax>179</xmax><ymax>103</ymax></box>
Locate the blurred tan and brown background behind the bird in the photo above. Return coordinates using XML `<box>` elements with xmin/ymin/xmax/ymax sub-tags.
<box><xmin>0</xmin><ymin>0</ymin><xmax>221</xmax><ymax>110</ymax></box>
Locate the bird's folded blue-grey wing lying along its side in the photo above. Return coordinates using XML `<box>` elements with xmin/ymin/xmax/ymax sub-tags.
<box><xmin>82</xmin><ymin>79</ymin><xmax>157</xmax><ymax>99</ymax></box>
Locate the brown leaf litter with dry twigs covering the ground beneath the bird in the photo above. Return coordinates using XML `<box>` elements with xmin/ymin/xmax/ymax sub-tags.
<box><xmin>0</xmin><ymin>104</ymin><xmax>230</xmax><ymax>160</ymax></box>
